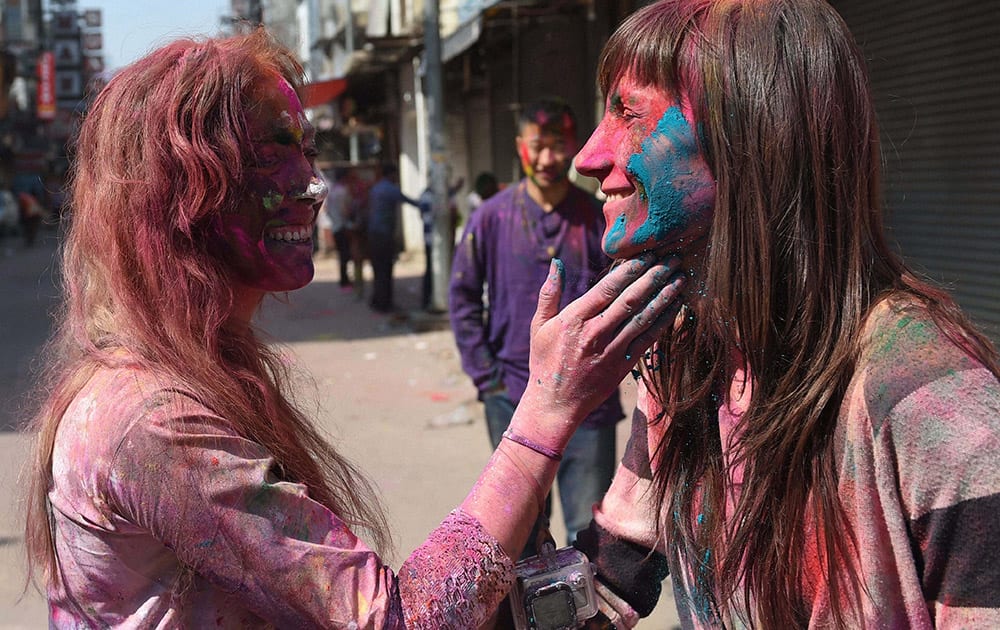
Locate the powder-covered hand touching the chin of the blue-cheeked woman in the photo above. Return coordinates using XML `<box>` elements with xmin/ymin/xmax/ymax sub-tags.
<box><xmin>515</xmin><ymin>253</ymin><xmax>685</xmax><ymax>446</ymax></box>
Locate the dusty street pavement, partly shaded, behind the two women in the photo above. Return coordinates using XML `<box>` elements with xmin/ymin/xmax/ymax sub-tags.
<box><xmin>0</xmin><ymin>232</ymin><xmax>679</xmax><ymax>630</ymax></box>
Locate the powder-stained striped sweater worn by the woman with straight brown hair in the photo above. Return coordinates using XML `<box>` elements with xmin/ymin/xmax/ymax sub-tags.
<box><xmin>578</xmin><ymin>305</ymin><xmax>1000</xmax><ymax>628</ymax></box>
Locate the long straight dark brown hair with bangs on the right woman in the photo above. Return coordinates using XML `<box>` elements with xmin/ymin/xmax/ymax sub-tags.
<box><xmin>598</xmin><ymin>0</ymin><xmax>998</xmax><ymax>628</ymax></box>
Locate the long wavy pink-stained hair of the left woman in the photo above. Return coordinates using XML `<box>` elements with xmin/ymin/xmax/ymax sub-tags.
<box><xmin>25</xmin><ymin>29</ymin><xmax>390</xmax><ymax>592</ymax></box>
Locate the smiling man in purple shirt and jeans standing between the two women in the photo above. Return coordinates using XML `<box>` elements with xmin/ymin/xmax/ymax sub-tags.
<box><xmin>449</xmin><ymin>99</ymin><xmax>624</xmax><ymax>555</ymax></box>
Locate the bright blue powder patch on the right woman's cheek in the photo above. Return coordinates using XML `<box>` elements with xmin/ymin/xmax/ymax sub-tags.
<box><xmin>628</xmin><ymin>106</ymin><xmax>692</xmax><ymax>243</ymax></box>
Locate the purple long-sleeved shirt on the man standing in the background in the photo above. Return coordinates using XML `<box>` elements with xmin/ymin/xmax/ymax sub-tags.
<box><xmin>449</xmin><ymin>180</ymin><xmax>624</xmax><ymax>427</ymax></box>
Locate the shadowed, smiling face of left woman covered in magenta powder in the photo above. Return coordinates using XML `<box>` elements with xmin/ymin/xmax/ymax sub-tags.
<box><xmin>216</xmin><ymin>75</ymin><xmax>327</xmax><ymax>292</ymax></box>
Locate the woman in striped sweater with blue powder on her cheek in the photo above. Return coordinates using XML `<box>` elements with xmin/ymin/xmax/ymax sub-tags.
<box><xmin>576</xmin><ymin>0</ymin><xmax>1000</xmax><ymax>629</ymax></box>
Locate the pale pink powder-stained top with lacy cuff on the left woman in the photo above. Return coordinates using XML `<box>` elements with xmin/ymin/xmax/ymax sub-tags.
<box><xmin>49</xmin><ymin>368</ymin><xmax>513</xmax><ymax>628</ymax></box>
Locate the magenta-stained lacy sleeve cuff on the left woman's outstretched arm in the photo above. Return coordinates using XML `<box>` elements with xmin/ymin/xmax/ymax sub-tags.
<box><xmin>399</xmin><ymin>510</ymin><xmax>514</xmax><ymax>630</ymax></box>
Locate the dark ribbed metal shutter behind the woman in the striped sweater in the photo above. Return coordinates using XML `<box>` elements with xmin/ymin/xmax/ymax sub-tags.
<box><xmin>831</xmin><ymin>0</ymin><xmax>1000</xmax><ymax>341</ymax></box>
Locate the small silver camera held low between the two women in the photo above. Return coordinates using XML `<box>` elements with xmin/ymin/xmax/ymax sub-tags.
<box><xmin>510</xmin><ymin>545</ymin><xmax>597</xmax><ymax>630</ymax></box>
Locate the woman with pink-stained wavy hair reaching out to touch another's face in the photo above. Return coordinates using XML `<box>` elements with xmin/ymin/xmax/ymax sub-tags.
<box><xmin>26</xmin><ymin>30</ymin><xmax>681</xmax><ymax>629</ymax></box>
